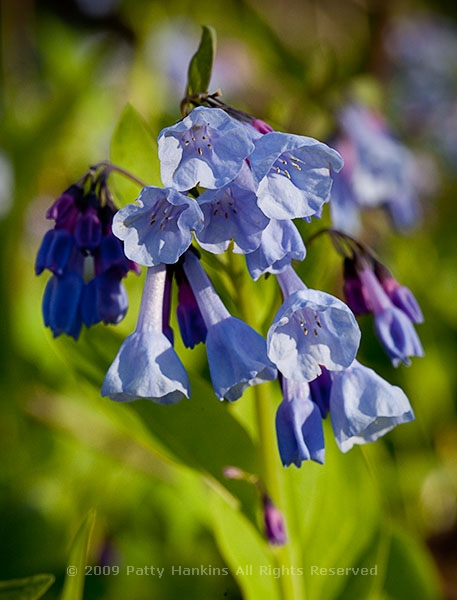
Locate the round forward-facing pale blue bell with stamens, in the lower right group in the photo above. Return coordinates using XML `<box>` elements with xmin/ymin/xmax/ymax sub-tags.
<box><xmin>267</xmin><ymin>267</ymin><xmax>360</xmax><ymax>381</ymax></box>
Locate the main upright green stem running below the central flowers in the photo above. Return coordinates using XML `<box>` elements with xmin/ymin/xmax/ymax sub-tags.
<box><xmin>230</xmin><ymin>255</ymin><xmax>306</xmax><ymax>600</ymax></box>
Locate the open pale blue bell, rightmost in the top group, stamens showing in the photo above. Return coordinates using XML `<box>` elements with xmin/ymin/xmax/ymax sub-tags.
<box><xmin>249</xmin><ymin>131</ymin><xmax>343</xmax><ymax>219</ymax></box>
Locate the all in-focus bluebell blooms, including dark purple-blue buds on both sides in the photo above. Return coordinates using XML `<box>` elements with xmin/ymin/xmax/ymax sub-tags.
<box><xmin>37</xmin><ymin>103</ymin><xmax>422</xmax><ymax>472</ymax></box>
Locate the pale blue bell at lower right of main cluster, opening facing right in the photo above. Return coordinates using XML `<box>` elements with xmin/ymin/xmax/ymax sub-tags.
<box><xmin>329</xmin><ymin>360</ymin><xmax>414</xmax><ymax>452</ymax></box>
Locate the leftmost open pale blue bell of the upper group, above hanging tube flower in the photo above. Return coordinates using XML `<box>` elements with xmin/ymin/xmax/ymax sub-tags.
<box><xmin>113</xmin><ymin>186</ymin><xmax>203</xmax><ymax>267</ymax></box>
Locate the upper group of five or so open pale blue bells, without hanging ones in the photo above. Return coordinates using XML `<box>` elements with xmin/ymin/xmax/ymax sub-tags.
<box><xmin>113</xmin><ymin>106</ymin><xmax>343</xmax><ymax>279</ymax></box>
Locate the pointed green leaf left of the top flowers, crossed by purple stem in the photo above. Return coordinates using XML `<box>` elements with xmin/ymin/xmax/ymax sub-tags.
<box><xmin>110</xmin><ymin>104</ymin><xmax>161</xmax><ymax>204</ymax></box>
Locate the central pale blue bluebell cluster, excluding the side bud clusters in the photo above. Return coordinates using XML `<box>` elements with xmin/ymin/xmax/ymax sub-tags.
<box><xmin>97</xmin><ymin>106</ymin><xmax>420</xmax><ymax>466</ymax></box>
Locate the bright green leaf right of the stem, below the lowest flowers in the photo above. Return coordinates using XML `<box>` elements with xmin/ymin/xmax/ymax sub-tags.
<box><xmin>287</xmin><ymin>421</ymin><xmax>381</xmax><ymax>600</ymax></box>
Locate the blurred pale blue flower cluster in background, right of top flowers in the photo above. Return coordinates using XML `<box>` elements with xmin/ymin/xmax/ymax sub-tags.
<box><xmin>330</xmin><ymin>103</ymin><xmax>420</xmax><ymax>235</ymax></box>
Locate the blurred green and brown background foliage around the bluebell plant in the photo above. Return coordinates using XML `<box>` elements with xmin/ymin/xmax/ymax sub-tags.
<box><xmin>0</xmin><ymin>0</ymin><xmax>457</xmax><ymax>600</ymax></box>
